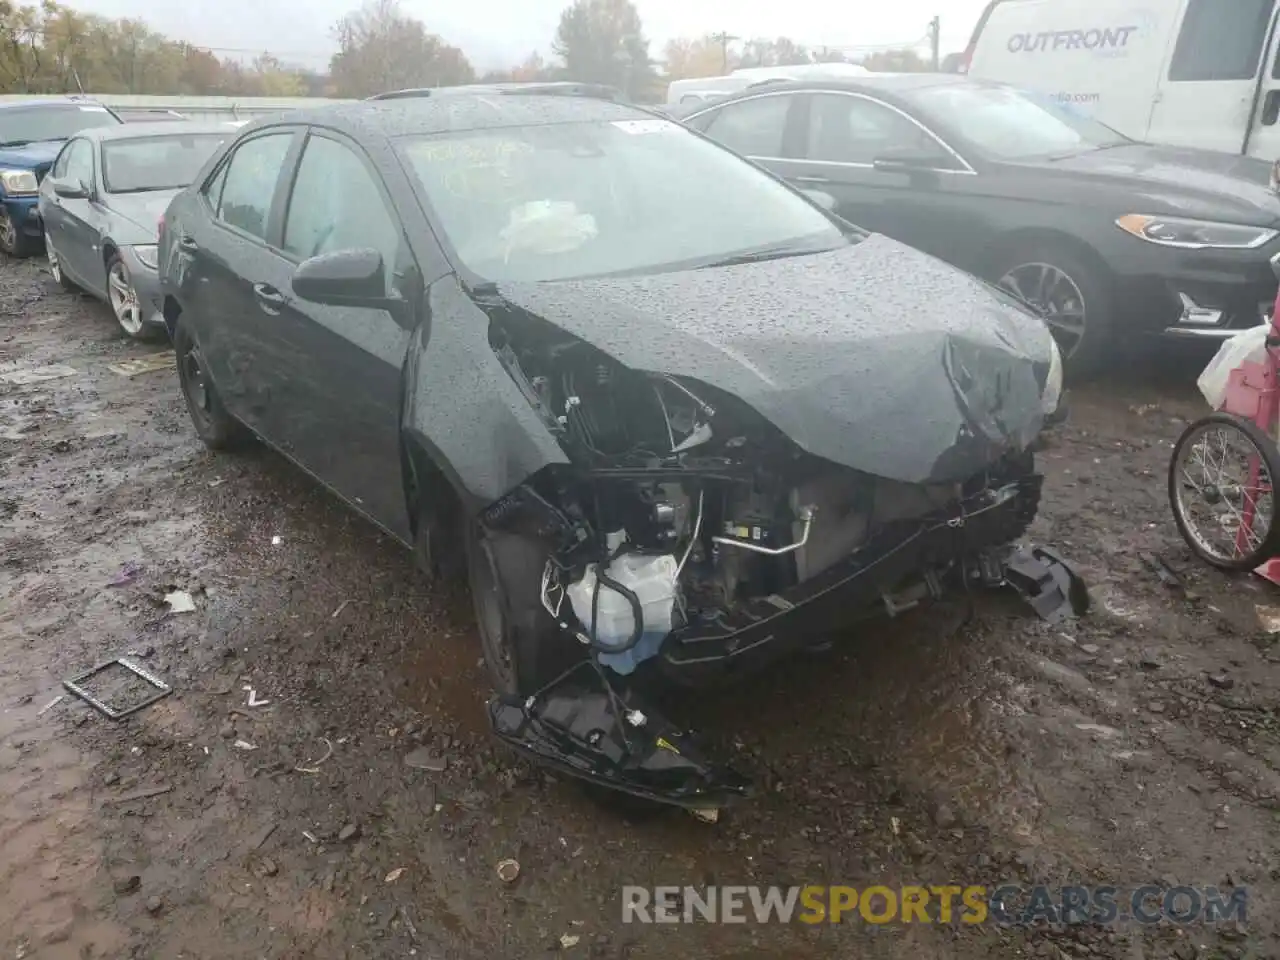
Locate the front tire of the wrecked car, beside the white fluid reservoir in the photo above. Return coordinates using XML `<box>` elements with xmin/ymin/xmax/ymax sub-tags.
<box><xmin>465</xmin><ymin>524</ymin><xmax>584</xmax><ymax>696</ymax></box>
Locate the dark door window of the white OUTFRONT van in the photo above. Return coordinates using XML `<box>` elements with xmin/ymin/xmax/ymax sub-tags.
<box><xmin>1169</xmin><ymin>0</ymin><xmax>1275</xmax><ymax>81</ymax></box>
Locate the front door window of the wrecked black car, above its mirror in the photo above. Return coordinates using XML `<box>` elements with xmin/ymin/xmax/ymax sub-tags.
<box><xmin>284</xmin><ymin>136</ymin><xmax>401</xmax><ymax>288</ymax></box>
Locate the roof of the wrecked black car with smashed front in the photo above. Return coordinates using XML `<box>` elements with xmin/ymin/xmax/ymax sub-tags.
<box><xmin>258</xmin><ymin>93</ymin><xmax>652</xmax><ymax>137</ymax></box>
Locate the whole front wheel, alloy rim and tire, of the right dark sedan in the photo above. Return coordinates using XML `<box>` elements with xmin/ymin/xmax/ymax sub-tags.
<box><xmin>992</xmin><ymin>242</ymin><xmax>1112</xmax><ymax>376</ymax></box>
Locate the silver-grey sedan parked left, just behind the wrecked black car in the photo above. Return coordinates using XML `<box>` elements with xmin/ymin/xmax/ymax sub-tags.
<box><xmin>40</xmin><ymin>120</ymin><xmax>236</xmax><ymax>339</ymax></box>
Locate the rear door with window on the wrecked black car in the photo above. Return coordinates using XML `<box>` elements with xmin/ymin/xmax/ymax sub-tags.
<box><xmin>174</xmin><ymin>127</ymin><xmax>302</xmax><ymax>427</ymax></box>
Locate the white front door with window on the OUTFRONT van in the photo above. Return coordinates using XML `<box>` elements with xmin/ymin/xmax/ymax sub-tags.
<box><xmin>1146</xmin><ymin>0</ymin><xmax>1280</xmax><ymax>154</ymax></box>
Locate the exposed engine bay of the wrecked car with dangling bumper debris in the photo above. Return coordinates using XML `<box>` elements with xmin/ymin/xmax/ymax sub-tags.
<box><xmin>471</xmin><ymin>310</ymin><xmax>1087</xmax><ymax>808</ymax></box>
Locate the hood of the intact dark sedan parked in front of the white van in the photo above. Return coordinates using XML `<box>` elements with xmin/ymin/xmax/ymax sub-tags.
<box><xmin>1024</xmin><ymin>143</ymin><xmax>1280</xmax><ymax>227</ymax></box>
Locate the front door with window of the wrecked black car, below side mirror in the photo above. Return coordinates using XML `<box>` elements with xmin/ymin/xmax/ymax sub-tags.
<box><xmin>252</xmin><ymin>129</ymin><xmax>422</xmax><ymax>540</ymax></box>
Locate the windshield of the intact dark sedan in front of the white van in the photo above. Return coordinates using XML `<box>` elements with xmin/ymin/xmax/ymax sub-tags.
<box><xmin>908</xmin><ymin>83</ymin><xmax>1130</xmax><ymax>160</ymax></box>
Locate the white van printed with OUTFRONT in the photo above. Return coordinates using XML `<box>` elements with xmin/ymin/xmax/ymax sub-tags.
<box><xmin>959</xmin><ymin>0</ymin><xmax>1280</xmax><ymax>160</ymax></box>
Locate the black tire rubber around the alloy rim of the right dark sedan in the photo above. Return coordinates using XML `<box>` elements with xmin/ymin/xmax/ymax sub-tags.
<box><xmin>991</xmin><ymin>241</ymin><xmax>1115</xmax><ymax>379</ymax></box>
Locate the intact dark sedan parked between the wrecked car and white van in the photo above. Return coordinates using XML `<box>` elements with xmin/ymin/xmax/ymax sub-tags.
<box><xmin>676</xmin><ymin>73</ymin><xmax>1280</xmax><ymax>374</ymax></box>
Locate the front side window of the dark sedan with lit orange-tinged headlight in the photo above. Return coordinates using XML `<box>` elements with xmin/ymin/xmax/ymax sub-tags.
<box><xmin>805</xmin><ymin>93</ymin><xmax>955</xmax><ymax>169</ymax></box>
